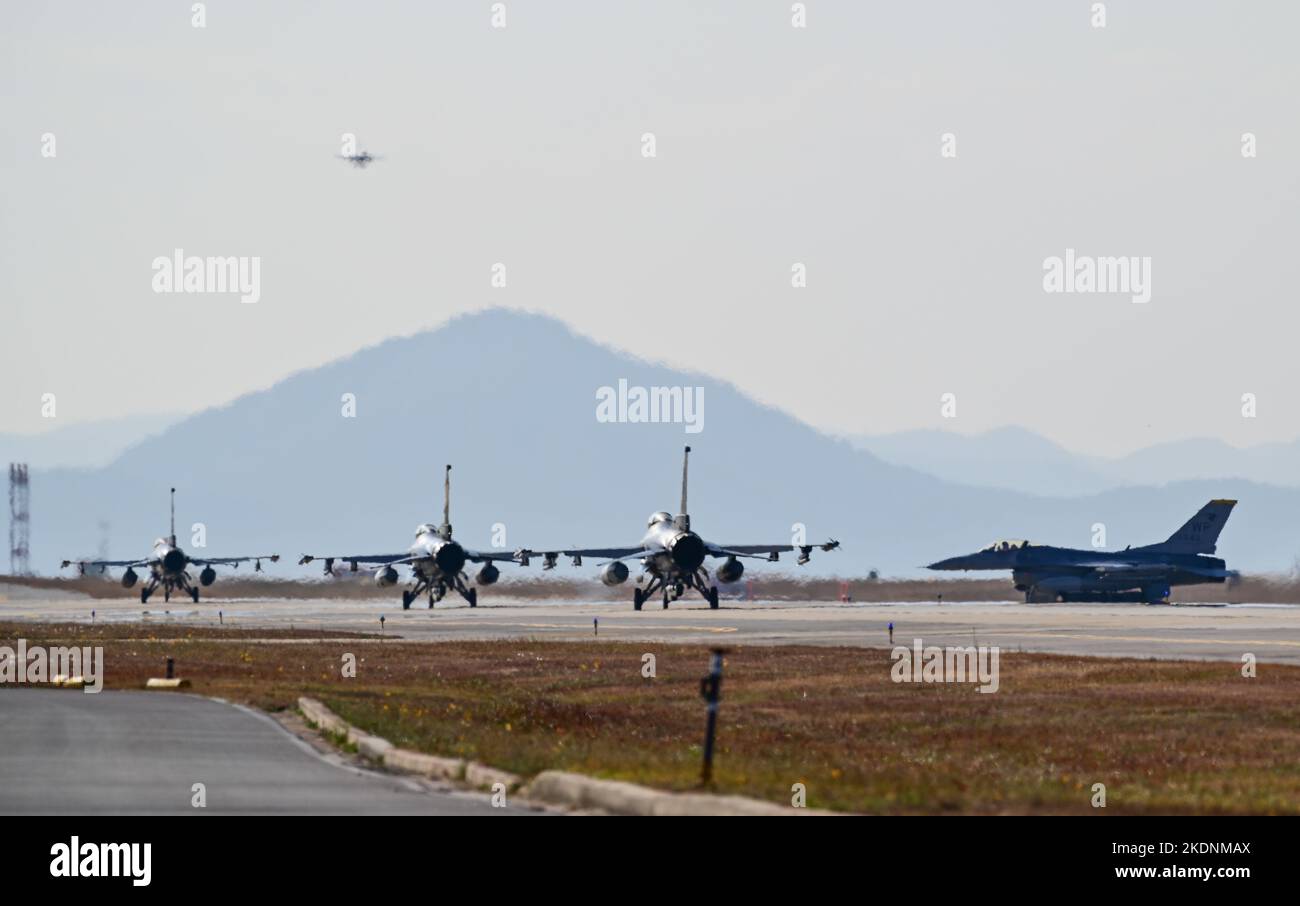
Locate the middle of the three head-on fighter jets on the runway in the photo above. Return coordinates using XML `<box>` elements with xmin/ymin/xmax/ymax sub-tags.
<box><xmin>298</xmin><ymin>465</ymin><xmax>515</xmax><ymax>610</ymax></box>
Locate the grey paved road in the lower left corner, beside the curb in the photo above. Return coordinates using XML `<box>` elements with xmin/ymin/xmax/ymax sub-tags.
<box><xmin>0</xmin><ymin>689</ymin><xmax>536</xmax><ymax>815</ymax></box>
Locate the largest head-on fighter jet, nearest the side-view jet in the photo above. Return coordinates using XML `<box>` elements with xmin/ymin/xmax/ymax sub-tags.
<box><xmin>517</xmin><ymin>447</ymin><xmax>840</xmax><ymax>610</ymax></box>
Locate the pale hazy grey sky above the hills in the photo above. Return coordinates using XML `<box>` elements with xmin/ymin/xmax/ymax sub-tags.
<box><xmin>0</xmin><ymin>0</ymin><xmax>1300</xmax><ymax>454</ymax></box>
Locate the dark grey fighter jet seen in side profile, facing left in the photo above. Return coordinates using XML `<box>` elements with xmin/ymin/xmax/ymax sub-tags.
<box><xmin>928</xmin><ymin>500</ymin><xmax>1238</xmax><ymax>604</ymax></box>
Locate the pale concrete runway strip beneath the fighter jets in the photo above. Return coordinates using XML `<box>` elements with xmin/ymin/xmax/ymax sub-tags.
<box><xmin>0</xmin><ymin>585</ymin><xmax>1300</xmax><ymax>664</ymax></box>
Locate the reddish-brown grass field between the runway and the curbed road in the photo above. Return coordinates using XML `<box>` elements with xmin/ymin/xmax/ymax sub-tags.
<box><xmin>0</xmin><ymin>624</ymin><xmax>1300</xmax><ymax>814</ymax></box>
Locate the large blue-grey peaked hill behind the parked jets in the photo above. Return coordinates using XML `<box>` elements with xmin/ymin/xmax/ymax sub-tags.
<box><xmin>12</xmin><ymin>311</ymin><xmax>1300</xmax><ymax>576</ymax></box>
